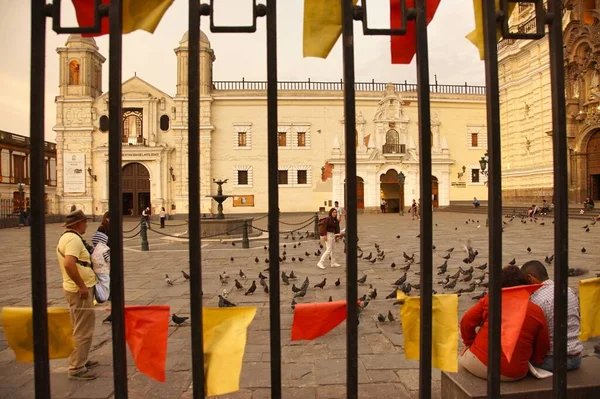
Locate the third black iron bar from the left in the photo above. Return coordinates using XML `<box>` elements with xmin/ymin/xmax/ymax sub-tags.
<box><xmin>188</xmin><ymin>0</ymin><xmax>205</xmax><ymax>399</ymax></box>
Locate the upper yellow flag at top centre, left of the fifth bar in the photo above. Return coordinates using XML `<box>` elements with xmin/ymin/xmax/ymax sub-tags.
<box><xmin>303</xmin><ymin>0</ymin><xmax>358</xmax><ymax>58</ymax></box>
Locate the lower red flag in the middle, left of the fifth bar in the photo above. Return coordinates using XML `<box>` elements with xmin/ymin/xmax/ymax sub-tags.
<box><xmin>292</xmin><ymin>301</ymin><xmax>346</xmax><ymax>341</ymax></box>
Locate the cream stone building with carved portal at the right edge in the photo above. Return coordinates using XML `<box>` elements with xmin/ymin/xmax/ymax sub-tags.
<box><xmin>498</xmin><ymin>0</ymin><xmax>600</xmax><ymax>204</ymax></box>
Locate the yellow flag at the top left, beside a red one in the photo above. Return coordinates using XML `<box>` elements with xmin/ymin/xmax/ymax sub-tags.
<box><xmin>123</xmin><ymin>0</ymin><xmax>173</xmax><ymax>33</ymax></box>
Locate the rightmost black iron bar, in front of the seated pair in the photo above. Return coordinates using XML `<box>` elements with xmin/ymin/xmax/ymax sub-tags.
<box><xmin>548</xmin><ymin>0</ymin><xmax>569</xmax><ymax>399</ymax></box>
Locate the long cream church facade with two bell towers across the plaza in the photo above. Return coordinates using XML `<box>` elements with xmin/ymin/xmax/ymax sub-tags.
<box><xmin>54</xmin><ymin>32</ymin><xmax>487</xmax><ymax>215</ymax></box>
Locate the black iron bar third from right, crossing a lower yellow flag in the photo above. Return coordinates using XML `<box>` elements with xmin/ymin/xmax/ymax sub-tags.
<box><xmin>415</xmin><ymin>0</ymin><xmax>433</xmax><ymax>399</ymax></box>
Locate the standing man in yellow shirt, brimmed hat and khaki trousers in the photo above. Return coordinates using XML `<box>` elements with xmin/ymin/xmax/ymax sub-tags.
<box><xmin>56</xmin><ymin>210</ymin><xmax>98</xmax><ymax>381</ymax></box>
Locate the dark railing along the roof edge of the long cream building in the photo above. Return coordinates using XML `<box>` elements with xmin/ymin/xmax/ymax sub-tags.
<box><xmin>213</xmin><ymin>79</ymin><xmax>485</xmax><ymax>95</ymax></box>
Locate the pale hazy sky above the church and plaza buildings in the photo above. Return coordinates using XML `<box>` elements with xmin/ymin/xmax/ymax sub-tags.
<box><xmin>0</xmin><ymin>0</ymin><xmax>485</xmax><ymax>141</ymax></box>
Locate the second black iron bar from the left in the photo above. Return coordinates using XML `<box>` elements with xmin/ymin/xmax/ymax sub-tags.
<box><xmin>108</xmin><ymin>0</ymin><xmax>127</xmax><ymax>398</ymax></box>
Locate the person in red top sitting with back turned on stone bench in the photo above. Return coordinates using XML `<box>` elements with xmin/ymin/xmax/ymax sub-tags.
<box><xmin>459</xmin><ymin>266</ymin><xmax>550</xmax><ymax>381</ymax></box>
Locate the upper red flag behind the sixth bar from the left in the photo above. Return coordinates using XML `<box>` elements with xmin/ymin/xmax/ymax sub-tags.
<box><xmin>390</xmin><ymin>0</ymin><xmax>441</xmax><ymax>64</ymax></box>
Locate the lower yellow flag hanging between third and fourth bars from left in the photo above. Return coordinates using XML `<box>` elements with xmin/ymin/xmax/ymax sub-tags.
<box><xmin>202</xmin><ymin>307</ymin><xmax>256</xmax><ymax>396</ymax></box>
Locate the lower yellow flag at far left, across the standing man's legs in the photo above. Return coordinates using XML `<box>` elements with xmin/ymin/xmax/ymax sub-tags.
<box><xmin>2</xmin><ymin>307</ymin><xmax>75</xmax><ymax>362</ymax></box>
